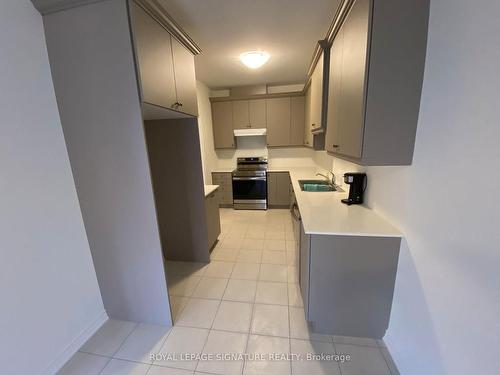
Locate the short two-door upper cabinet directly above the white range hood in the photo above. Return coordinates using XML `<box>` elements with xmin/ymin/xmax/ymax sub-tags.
<box><xmin>232</xmin><ymin>99</ymin><xmax>267</xmax><ymax>129</ymax></box>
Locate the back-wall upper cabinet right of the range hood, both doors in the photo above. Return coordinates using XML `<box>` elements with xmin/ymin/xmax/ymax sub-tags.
<box><xmin>267</xmin><ymin>96</ymin><xmax>305</xmax><ymax>147</ymax></box>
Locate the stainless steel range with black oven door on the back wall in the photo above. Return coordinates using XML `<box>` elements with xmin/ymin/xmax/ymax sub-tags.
<box><xmin>233</xmin><ymin>157</ymin><xmax>267</xmax><ymax>210</ymax></box>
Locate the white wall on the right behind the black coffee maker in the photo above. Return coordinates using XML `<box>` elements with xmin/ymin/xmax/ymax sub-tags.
<box><xmin>316</xmin><ymin>0</ymin><xmax>500</xmax><ymax>375</ymax></box>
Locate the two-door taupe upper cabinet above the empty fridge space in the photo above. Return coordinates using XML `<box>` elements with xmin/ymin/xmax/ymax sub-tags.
<box><xmin>131</xmin><ymin>0</ymin><xmax>198</xmax><ymax>119</ymax></box>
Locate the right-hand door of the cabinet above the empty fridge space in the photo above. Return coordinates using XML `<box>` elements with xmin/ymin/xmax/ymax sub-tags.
<box><xmin>171</xmin><ymin>37</ymin><xmax>198</xmax><ymax>116</ymax></box>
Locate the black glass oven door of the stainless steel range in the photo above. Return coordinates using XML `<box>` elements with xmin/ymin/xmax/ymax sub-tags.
<box><xmin>233</xmin><ymin>176</ymin><xmax>267</xmax><ymax>209</ymax></box>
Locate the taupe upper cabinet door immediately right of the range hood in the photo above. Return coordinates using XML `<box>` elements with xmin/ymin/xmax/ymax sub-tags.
<box><xmin>267</xmin><ymin>98</ymin><xmax>290</xmax><ymax>146</ymax></box>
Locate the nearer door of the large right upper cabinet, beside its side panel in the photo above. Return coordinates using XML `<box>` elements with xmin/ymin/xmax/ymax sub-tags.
<box><xmin>338</xmin><ymin>0</ymin><xmax>370</xmax><ymax>158</ymax></box>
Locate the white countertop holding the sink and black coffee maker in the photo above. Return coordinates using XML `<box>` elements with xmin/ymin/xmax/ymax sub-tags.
<box><xmin>288</xmin><ymin>168</ymin><xmax>403</xmax><ymax>237</ymax></box>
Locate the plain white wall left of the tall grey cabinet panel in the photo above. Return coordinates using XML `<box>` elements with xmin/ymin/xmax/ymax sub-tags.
<box><xmin>0</xmin><ymin>0</ymin><xmax>106</xmax><ymax>375</ymax></box>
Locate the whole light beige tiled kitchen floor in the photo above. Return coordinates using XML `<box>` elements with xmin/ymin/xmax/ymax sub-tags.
<box><xmin>60</xmin><ymin>209</ymin><xmax>399</xmax><ymax>375</ymax></box>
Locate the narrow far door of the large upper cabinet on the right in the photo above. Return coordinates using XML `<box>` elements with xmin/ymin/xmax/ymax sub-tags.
<box><xmin>325</xmin><ymin>29</ymin><xmax>344</xmax><ymax>152</ymax></box>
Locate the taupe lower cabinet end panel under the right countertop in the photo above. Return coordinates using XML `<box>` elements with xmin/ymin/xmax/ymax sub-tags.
<box><xmin>299</xmin><ymin>225</ymin><xmax>401</xmax><ymax>339</ymax></box>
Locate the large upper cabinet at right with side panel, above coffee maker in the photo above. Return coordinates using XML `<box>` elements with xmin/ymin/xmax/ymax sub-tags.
<box><xmin>325</xmin><ymin>0</ymin><xmax>429</xmax><ymax>165</ymax></box>
